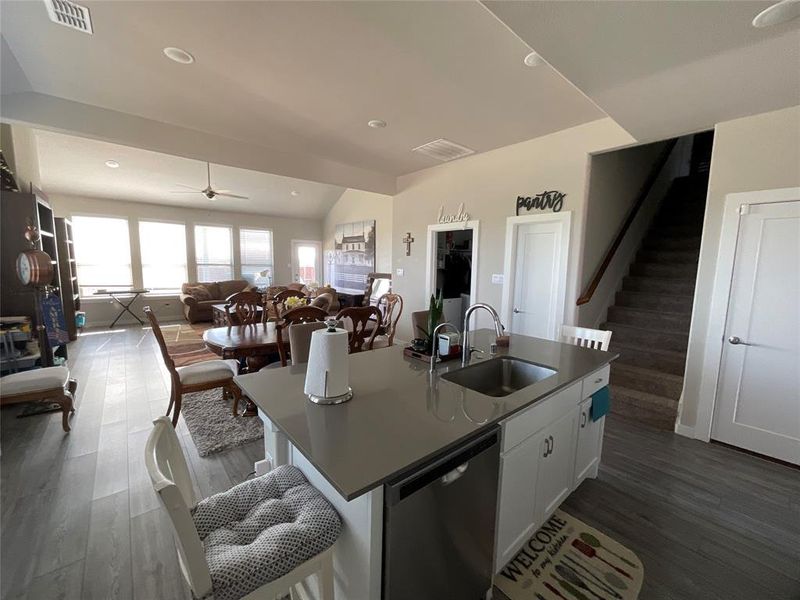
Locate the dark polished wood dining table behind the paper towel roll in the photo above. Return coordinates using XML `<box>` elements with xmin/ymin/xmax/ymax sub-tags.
<box><xmin>203</xmin><ymin>322</ymin><xmax>289</xmax><ymax>417</ymax></box>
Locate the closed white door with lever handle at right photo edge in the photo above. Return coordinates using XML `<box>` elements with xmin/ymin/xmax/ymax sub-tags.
<box><xmin>711</xmin><ymin>200</ymin><xmax>800</xmax><ymax>464</ymax></box>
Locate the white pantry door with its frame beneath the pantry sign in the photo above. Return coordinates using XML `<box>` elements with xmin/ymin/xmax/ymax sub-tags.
<box><xmin>503</xmin><ymin>213</ymin><xmax>569</xmax><ymax>340</ymax></box>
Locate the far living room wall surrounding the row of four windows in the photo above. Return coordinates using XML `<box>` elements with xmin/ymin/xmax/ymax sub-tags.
<box><xmin>49</xmin><ymin>194</ymin><xmax>322</xmax><ymax>325</ymax></box>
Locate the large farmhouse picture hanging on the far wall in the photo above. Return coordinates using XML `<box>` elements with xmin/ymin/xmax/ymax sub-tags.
<box><xmin>331</xmin><ymin>220</ymin><xmax>375</xmax><ymax>294</ymax></box>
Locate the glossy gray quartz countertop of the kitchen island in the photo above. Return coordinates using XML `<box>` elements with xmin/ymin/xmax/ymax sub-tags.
<box><xmin>235</xmin><ymin>329</ymin><xmax>616</xmax><ymax>500</ymax></box>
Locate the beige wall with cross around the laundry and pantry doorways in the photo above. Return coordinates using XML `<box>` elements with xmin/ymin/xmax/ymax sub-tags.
<box><xmin>392</xmin><ymin>118</ymin><xmax>634</xmax><ymax>339</ymax></box>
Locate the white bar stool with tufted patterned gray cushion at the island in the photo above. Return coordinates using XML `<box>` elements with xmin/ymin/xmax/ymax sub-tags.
<box><xmin>144</xmin><ymin>417</ymin><xmax>342</xmax><ymax>600</ymax></box>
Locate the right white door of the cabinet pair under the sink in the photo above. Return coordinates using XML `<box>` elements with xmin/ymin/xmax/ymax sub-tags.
<box><xmin>536</xmin><ymin>409</ymin><xmax>578</xmax><ymax>523</ymax></box>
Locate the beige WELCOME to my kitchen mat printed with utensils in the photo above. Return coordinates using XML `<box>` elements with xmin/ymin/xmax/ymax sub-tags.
<box><xmin>494</xmin><ymin>510</ymin><xmax>644</xmax><ymax>600</ymax></box>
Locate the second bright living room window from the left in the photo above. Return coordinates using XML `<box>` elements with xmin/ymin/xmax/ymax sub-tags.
<box><xmin>139</xmin><ymin>221</ymin><xmax>189</xmax><ymax>293</ymax></box>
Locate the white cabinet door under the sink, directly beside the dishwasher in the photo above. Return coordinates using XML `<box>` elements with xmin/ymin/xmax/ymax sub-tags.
<box><xmin>495</xmin><ymin>433</ymin><xmax>542</xmax><ymax>572</ymax></box>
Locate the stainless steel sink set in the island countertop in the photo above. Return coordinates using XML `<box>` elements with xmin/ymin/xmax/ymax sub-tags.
<box><xmin>442</xmin><ymin>356</ymin><xmax>556</xmax><ymax>398</ymax></box>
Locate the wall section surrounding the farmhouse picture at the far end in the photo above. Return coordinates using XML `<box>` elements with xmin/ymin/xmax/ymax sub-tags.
<box><xmin>322</xmin><ymin>189</ymin><xmax>393</xmax><ymax>281</ymax></box>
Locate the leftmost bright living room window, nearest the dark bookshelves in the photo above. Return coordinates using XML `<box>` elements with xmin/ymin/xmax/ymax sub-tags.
<box><xmin>72</xmin><ymin>217</ymin><xmax>133</xmax><ymax>296</ymax></box>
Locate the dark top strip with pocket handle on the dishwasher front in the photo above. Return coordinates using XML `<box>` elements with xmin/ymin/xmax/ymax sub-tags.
<box><xmin>384</xmin><ymin>427</ymin><xmax>499</xmax><ymax>506</ymax></box>
